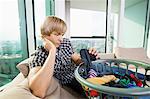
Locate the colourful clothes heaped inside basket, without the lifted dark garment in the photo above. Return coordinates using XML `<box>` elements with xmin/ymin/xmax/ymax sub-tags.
<box><xmin>83</xmin><ymin>62</ymin><xmax>150</xmax><ymax>97</ymax></box>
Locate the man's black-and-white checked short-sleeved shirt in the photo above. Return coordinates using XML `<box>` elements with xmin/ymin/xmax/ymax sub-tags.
<box><xmin>30</xmin><ymin>38</ymin><xmax>76</xmax><ymax>84</ymax></box>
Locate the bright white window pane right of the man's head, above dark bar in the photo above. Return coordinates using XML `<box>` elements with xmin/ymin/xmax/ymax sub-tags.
<box><xmin>70</xmin><ymin>8</ymin><xmax>106</xmax><ymax>37</ymax></box>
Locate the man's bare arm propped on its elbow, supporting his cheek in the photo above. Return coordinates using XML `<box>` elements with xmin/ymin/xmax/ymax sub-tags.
<box><xmin>29</xmin><ymin>38</ymin><xmax>56</xmax><ymax>98</ymax></box>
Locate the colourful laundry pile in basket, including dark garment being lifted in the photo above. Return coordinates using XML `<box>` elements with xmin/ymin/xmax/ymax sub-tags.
<box><xmin>79</xmin><ymin>49</ymin><xmax>150</xmax><ymax>97</ymax></box>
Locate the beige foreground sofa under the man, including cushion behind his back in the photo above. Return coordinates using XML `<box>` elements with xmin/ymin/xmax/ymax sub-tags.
<box><xmin>0</xmin><ymin>57</ymin><xmax>84</xmax><ymax>99</ymax></box>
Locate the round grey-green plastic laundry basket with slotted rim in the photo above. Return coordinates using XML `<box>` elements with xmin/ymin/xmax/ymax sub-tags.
<box><xmin>75</xmin><ymin>59</ymin><xmax>150</xmax><ymax>99</ymax></box>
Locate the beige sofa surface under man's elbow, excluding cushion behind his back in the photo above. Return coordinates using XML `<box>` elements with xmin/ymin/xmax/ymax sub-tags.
<box><xmin>0</xmin><ymin>73</ymin><xmax>80</xmax><ymax>99</ymax></box>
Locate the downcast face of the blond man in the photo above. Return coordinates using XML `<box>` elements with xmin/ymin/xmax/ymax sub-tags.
<box><xmin>48</xmin><ymin>32</ymin><xmax>64</xmax><ymax>47</ymax></box>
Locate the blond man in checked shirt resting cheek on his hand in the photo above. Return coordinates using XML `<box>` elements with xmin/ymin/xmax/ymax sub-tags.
<box><xmin>29</xmin><ymin>16</ymin><xmax>99</xmax><ymax>98</ymax></box>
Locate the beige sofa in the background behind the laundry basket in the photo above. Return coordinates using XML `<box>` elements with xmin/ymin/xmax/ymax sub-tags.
<box><xmin>100</xmin><ymin>47</ymin><xmax>150</xmax><ymax>64</ymax></box>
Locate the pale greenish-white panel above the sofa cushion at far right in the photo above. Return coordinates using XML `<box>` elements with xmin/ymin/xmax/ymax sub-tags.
<box><xmin>120</xmin><ymin>18</ymin><xmax>144</xmax><ymax>48</ymax></box>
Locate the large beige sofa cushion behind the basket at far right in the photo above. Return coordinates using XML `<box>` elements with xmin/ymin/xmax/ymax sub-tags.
<box><xmin>115</xmin><ymin>47</ymin><xmax>148</xmax><ymax>60</ymax></box>
